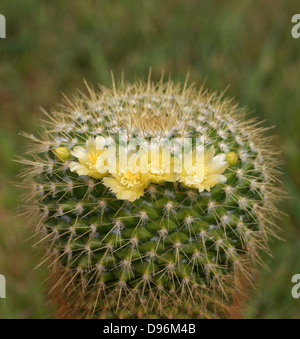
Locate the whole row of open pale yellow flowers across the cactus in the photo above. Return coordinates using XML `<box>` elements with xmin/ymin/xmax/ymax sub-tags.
<box><xmin>67</xmin><ymin>132</ymin><xmax>228</xmax><ymax>202</ymax></box>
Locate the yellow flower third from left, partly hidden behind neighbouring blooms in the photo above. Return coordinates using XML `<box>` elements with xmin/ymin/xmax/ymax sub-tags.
<box><xmin>146</xmin><ymin>145</ymin><xmax>177</xmax><ymax>184</ymax></box>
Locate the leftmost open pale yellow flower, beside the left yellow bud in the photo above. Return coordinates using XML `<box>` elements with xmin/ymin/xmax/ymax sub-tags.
<box><xmin>69</xmin><ymin>137</ymin><xmax>108</xmax><ymax>179</ymax></box>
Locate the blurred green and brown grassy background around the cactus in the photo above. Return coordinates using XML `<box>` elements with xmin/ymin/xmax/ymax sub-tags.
<box><xmin>0</xmin><ymin>0</ymin><xmax>300</xmax><ymax>318</ymax></box>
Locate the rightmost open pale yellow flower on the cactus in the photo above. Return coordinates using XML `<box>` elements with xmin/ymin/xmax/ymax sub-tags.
<box><xmin>178</xmin><ymin>147</ymin><xmax>228</xmax><ymax>192</ymax></box>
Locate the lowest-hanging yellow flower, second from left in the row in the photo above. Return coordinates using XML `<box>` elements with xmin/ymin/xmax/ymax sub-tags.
<box><xmin>103</xmin><ymin>167</ymin><xmax>149</xmax><ymax>202</ymax></box>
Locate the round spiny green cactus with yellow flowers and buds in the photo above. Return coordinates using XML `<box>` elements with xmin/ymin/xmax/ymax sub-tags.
<box><xmin>21</xmin><ymin>80</ymin><xmax>280</xmax><ymax>318</ymax></box>
